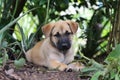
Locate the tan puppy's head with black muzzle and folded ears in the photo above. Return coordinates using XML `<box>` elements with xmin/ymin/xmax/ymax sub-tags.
<box><xmin>42</xmin><ymin>20</ymin><xmax>78</xmax><ymax>51</ymax></box>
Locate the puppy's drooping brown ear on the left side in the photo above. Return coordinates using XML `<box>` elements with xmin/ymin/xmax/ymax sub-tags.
<box><xmin>42</xmin><ymin>23</ymin><xmax>54</xmax><ymax>37</ymax></box>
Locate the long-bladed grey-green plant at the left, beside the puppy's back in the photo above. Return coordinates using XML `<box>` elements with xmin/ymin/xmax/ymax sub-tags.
<box><xmin>0</xmin><ymin>9</ymin><xmax>38</xmax><ymax>65</ymax></box>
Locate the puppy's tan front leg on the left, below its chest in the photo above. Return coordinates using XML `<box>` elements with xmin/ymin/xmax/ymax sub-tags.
<box><xmin>49</xmin><ymin>60</ymin><xmax>68</xmax><ymax>71</ymax></box>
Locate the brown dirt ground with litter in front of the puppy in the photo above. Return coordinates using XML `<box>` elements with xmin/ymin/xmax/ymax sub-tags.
<box><xmin>0</xmin><ymin>61</ymin><xmax>89</xmax><ymax>80</ymax></box>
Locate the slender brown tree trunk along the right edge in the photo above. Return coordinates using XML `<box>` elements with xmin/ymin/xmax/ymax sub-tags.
<box><xmin>108</xmin><ymin>0</ymin><xmax>120</xmax><ymax>53</ymax></box>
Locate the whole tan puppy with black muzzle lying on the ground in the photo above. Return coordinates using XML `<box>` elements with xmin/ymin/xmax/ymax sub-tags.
<box><xmin>26</xmin><ymin>20</ymin><xmax>83</xmax><ymax>71</ymax></box>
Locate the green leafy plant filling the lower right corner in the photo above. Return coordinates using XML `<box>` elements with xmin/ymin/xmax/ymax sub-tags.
<box><xmin>81</xmin><ymin>44</ymin><xmax>120</xmax><ymax>80</ymax></box>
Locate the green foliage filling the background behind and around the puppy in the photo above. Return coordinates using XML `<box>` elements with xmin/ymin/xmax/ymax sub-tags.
<box><xmin>0</xmin><ymin>0</ymin><xmax>120</xmax><ymax>80</ymax></box>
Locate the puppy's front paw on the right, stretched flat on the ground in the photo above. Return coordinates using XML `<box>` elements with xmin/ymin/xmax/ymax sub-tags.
<box><xmin>68</xmin><ymin>62</ymin><xmax>84</xmax><ymax>71</ymax></box>
